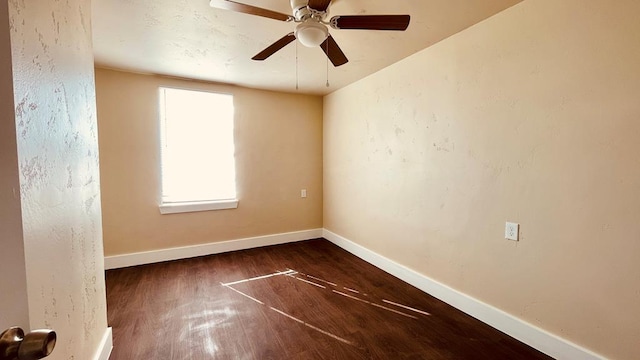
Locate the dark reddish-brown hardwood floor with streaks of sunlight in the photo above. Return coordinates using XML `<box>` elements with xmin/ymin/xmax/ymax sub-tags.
<box><xmin>107</xmin><ymin>239</ymin><xmax>549</xmax><ymax>360</ymax></box>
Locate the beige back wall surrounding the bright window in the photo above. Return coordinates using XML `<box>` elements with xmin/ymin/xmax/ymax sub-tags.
<box><xmin>96</xmin><ymin>69</ymin><xmax>322</xmax><ymax>256</ymax></box>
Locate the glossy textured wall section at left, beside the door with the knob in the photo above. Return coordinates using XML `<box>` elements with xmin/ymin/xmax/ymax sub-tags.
<box><xmin>8</xmin><ymin>0</ymin><xmax>107</xmax><ymax>360</ymax></box>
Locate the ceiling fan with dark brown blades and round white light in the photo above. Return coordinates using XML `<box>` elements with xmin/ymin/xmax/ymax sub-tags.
<box><xmin>210</xmin><ymin>0</ymin><xmax>411</xmax><ymax>66</ymax></box>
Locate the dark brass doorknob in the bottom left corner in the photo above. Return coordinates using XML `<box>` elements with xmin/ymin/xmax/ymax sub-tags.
<box><xmin>0</xmin><ymin>327</ymin><xmax>57</xmax><ymax>360</ymax></box>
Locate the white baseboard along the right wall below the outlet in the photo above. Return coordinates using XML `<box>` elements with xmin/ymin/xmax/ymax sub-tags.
<box><xmin>323</xmin><ymin>229</ymin><xmax>605</xmax><ymax>360</ymax></box>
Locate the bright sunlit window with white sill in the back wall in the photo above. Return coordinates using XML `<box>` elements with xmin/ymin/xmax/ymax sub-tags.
<box><xmin>160</xmin><ymin>88</ymin><xmax>238</xmax><ymax>214</ymax></box>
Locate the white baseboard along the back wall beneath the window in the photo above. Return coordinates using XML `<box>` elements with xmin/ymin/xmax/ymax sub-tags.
<box><xmin>104</xmin><ymin>229</ymin><xmax>322</xmax><ymax>270</ymax></box>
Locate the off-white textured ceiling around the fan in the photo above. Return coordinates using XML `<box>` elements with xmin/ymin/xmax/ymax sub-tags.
<box><xmin>92</xmin><ymin>0</ymin><xmax>521</xmax><ymax>94</ymax></box>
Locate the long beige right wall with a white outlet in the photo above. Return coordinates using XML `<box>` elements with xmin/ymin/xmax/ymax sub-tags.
<box><xmin>324</xmin><ymin>0</ymin><xmax>640</xmax><ymax>359</ymax></box>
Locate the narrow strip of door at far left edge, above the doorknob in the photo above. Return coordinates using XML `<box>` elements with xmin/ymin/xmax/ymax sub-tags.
<box><xmin>0</xmin><ymin>1</ymin><xmax>29</xmax><ymax>332</ymax></box>
